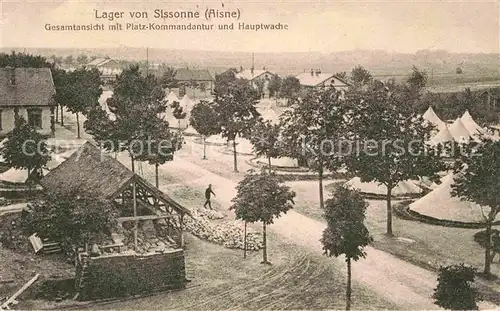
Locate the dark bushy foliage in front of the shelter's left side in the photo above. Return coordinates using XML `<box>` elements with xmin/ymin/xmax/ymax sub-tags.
<box><xmin>21</xmin><ymin>192</ymin><xmax>118</xmax><ymax>251</ymax></box>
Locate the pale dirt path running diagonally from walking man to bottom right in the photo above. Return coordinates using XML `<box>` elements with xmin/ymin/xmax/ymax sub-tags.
<box><xmin>152</xmin><ymin>158</ymin><xmax>496</xmax><ymax>310</ymax></box>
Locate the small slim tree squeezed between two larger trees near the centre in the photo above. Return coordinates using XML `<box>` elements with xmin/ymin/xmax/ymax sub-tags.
<box><xmin>250</xmin><ymin>121</ymin><xmax>281</xmax><ymax>172</ymax></box>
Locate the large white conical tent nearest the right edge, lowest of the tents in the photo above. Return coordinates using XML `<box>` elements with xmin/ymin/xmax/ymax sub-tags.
<box><xmin>410</xmin><ymin>174</ymin><xmax>500</xmax><ymax>222</ymax></box>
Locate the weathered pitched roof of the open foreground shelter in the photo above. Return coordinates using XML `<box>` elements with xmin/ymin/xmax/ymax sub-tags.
<box><xmin>40</xmin><ymin>142</ymin><xmax>190</xmax><ymax>214</ymax></box>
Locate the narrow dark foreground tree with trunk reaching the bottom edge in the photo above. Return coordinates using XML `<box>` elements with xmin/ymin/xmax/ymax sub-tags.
<box><xmin>321</xmin><ymin>186</ymin><xmax>373</xmax><ymax>310</ymax></box>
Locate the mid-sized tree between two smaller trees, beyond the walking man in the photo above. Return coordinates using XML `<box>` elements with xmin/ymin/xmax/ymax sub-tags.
<box><xmin>214</xmin><ymin>80</ymin><xmax>260</xmax><ymax>172</ymax></box>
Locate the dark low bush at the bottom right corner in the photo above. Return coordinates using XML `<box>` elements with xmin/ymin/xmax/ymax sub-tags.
<box><xmin>432</xmin><ymin>264</ymin><xmax>481</xmax><ymax>310</ymax></box>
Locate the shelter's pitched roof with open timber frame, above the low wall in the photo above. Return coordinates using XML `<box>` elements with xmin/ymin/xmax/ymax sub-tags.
<box><xmin>40</xmin><ymin>142</ymin><xmax>191</xmax><ymax>248</ymax></box>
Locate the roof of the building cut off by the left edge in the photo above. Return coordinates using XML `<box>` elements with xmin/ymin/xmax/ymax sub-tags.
<box><xmin>0</xmin><ymin>67</ymin><xmax>56</xmax><ymax>107</ymax></box>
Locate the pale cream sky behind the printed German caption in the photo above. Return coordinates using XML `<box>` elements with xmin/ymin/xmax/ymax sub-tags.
<box><xmin>0</xmin><ymin>0</ymin><xmax>500</xmax><ymax>53</ymax></box>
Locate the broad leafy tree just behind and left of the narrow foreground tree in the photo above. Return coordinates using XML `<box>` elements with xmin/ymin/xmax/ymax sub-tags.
<box><xmin>280</xmin><ymin>88</ymin><xmax>348</xmax><ymax>208</ymax></box>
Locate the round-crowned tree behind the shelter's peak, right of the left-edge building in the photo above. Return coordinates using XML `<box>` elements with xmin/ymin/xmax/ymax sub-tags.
<box><xmin>55</xmin><ymin>68</ymin><xmax>102</xmax><ymax>138</ymax></box>
